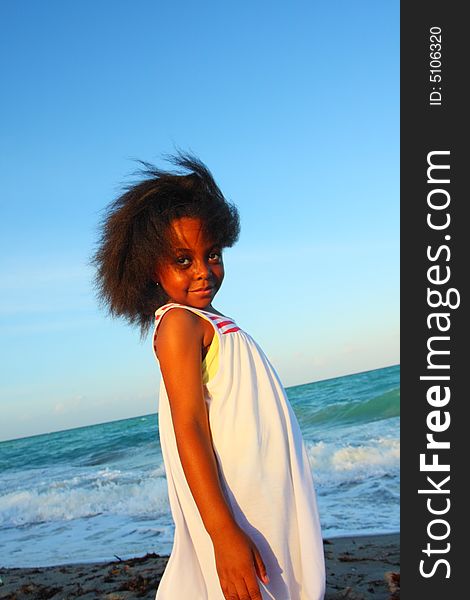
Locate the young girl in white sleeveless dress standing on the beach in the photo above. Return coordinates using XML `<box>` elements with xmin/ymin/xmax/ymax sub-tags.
<box><xmin>95</xmin><ymin>154</ymin><xmax>325</xmax><ymax>600</ymax></box>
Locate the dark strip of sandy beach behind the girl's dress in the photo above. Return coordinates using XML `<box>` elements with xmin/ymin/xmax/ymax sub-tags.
<box><xmin>0</xmin><ymin>534</ymin><xmax>400</xmax><ymax>600</ymax></box>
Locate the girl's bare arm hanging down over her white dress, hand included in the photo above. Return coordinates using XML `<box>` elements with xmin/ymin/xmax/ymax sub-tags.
<box><xmin>156</xmin><ymin>308</ymin><xmax>267</xmax><ymax>600</ymax></box>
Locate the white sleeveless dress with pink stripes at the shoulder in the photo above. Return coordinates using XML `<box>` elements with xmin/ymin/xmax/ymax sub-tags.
<box><xmin>153</xmin><ymin>303</ymin><xmax>325</xmax><ymax>600</ymax></box>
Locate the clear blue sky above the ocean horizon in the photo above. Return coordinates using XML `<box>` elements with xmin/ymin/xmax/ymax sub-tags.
<box><xmin>0</xmin><ymin>0</ymin><xmax>399</xmax><ymax>439</ymax></box>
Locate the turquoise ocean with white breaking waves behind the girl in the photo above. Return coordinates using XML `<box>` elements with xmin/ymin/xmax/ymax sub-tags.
<box><xmin>0</xmin><ymin>365</ymin><xmax>400</xmax><ymax>567</ymax></box>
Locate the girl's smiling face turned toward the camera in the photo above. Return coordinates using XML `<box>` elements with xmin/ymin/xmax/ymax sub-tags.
<box><xmin>155</xmin><ymin>217</ymin><xmax>224</xmax><ymax>309</ymax></box>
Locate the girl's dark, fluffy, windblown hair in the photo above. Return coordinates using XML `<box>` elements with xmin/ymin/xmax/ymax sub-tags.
<box><xmin>92</xmin><ymin>152</ymin><xmax>240</xmax><ymax>337</ymax></box>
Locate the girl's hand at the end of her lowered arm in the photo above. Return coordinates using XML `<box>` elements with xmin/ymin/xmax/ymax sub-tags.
<box><xmin>212</xmin><ymin>525</ymin><xmax>269</xmax><ymax>600</ymax></box>
